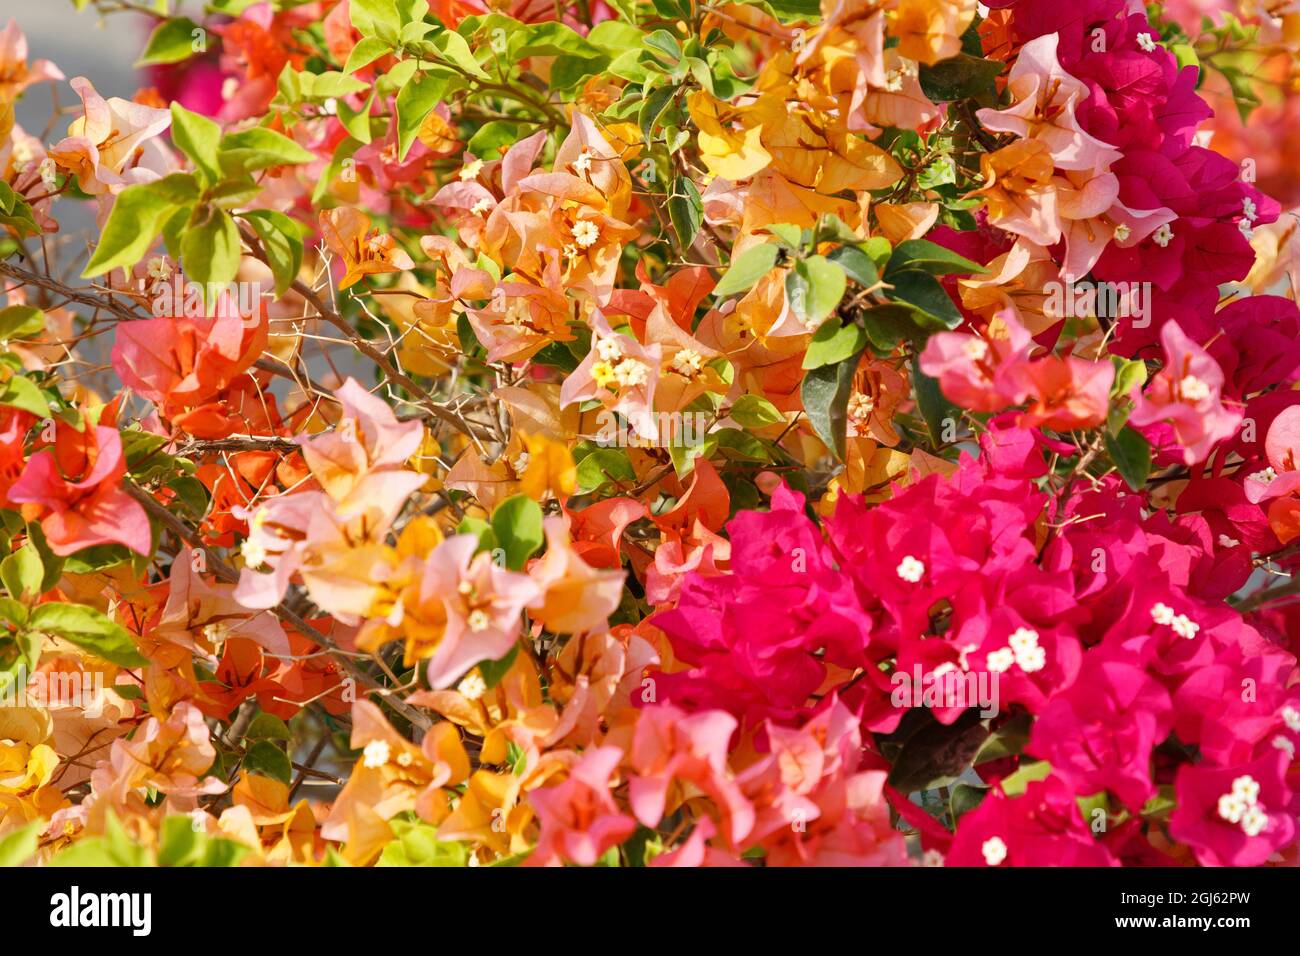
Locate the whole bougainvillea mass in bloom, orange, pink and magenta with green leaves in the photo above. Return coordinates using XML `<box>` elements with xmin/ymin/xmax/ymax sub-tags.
<box><xmin>0</xmin><ymin>0</ymin><xmax>1300</xmax><ymax>866</ymax></box>
